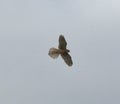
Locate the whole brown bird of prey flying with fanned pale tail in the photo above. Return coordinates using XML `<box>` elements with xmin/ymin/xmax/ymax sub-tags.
<box><xmin>48</xmin><ymin>35</ymin><xmax>73</xmax><ymax>66</ymax></box>
